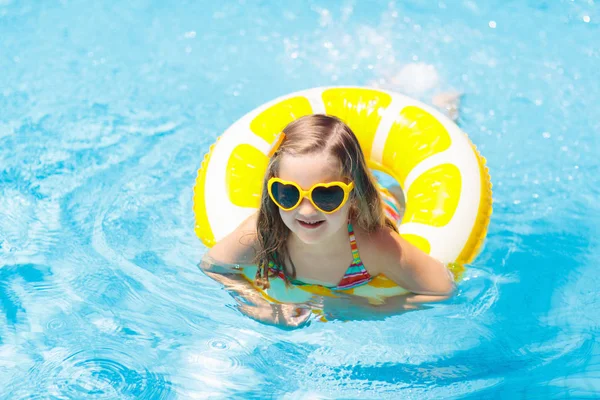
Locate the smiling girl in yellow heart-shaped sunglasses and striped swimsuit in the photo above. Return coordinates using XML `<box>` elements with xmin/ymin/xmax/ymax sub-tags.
<box><xmin>203</xmin><ymin>115</ymin><xmax>454</xmax><ymax>327</ymax></box>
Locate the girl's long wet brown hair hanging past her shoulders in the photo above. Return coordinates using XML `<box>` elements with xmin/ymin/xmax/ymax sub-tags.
<box><xmin>255</xmin><ymin>114</ymin><xmax>396</xmax><ymax>289</ymax></box>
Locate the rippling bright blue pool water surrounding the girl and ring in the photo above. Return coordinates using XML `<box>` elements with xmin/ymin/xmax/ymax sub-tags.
<box><xmin>0</xmin><ymin>0</ymin><xmax>600</xmax><ymax>399</ymax></box>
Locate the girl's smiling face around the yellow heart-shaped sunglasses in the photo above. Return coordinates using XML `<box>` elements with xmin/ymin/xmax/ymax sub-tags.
<box><xmin>277</xmin><ymin>153</ymin><xmax>350</xmax><ymax>244</ymax></box>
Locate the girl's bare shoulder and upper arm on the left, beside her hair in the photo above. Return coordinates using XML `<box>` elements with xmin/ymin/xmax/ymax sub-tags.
<box><xmin>208</xmin><ymin>213</ymin><xmax>259</xmax><ymax>264</ymax></box>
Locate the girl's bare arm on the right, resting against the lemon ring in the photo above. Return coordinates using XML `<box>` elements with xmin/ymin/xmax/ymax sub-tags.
<box><xmin>372</xmin><ymin>228</ymin><xmax>456</xmax><ymax>296</ymax></box>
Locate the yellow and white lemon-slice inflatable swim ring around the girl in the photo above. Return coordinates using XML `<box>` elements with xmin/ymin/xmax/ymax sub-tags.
<box><xmin>193</xmin><ymin>87</ymin><xmax>492</xmax><ymax>302</ymax></box>
